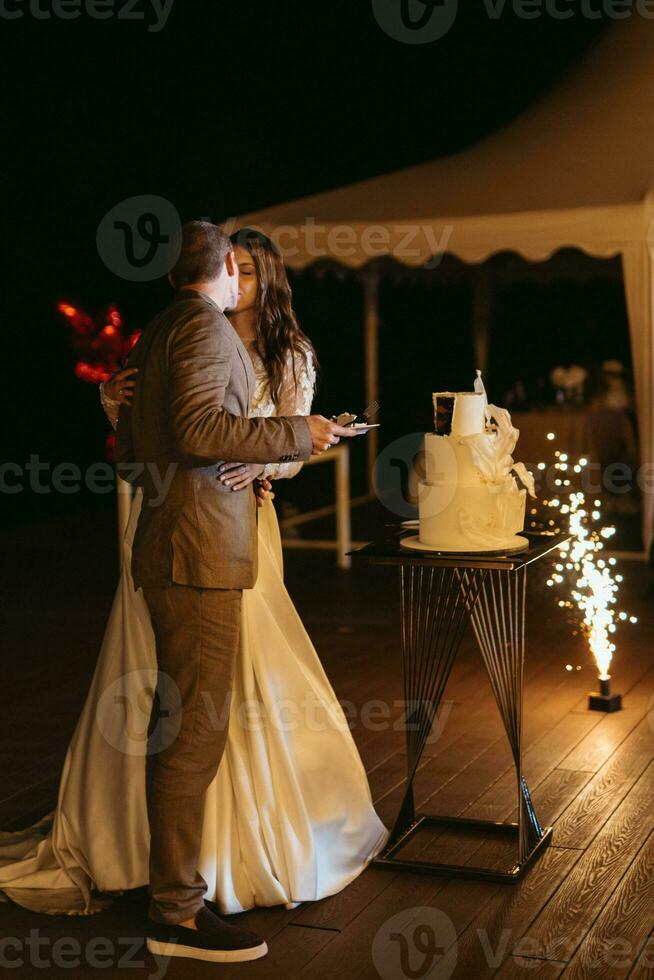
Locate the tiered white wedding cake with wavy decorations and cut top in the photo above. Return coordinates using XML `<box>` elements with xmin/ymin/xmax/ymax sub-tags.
<box><xmin>412</xmin><ymin>371</ymin><xmax>535</xmax><ymax>552</ymax></box>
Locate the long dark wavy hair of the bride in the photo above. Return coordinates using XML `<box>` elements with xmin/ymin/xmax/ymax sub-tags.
<box><xmin>231</xmin><ymin>228</ymin><xmax>318</xmax><ymax>406</ymax></box>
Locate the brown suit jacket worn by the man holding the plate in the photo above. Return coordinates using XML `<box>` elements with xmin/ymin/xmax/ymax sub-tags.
<box><xmin>116</xmin><ymin>289</ymin><xmax>311</xmax><ymax>589</ymax></box>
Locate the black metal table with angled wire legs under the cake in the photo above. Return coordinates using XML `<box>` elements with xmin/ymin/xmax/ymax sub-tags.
<box><xmin>352</xmin><ymin>530</ymin><xmax>568</xmax><ymax>882</ymax></box>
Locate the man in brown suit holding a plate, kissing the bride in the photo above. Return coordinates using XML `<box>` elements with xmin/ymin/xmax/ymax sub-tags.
<box><xmin>116</xmin><ymin>221</ymin><xmax>362</xmax><ymax>962</ymax></box>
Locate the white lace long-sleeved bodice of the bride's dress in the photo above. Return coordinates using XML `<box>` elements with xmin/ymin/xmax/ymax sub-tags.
<box><xmin>100</xmin><ymin>343</ymin><xmax>316</xmax><ymax>480</ymax></box>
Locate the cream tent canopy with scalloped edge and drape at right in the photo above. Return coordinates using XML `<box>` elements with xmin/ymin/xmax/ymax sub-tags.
<box><xmin>238</xmin><ymin>14</ymin><xmax>654</xmax><ymax>547</ymax></box>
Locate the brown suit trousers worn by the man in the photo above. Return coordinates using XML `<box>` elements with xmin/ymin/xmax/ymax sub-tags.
<box><xmin>143</xmin><ymin>585</ymin><xmax>242</xmax><ymax>924</ymax></box>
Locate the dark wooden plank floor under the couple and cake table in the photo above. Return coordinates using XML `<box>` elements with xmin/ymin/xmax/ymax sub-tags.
<box><xmin>0</xmin><ymin>506</ymin><xmax>654</xmax><ymax>980</ymax></box>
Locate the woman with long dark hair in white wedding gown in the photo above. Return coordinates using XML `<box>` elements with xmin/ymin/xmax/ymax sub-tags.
<box><xmin>0</xmin><ymin>229</ymin><xmax>388</xmax><ymax>914</ymax></box>
